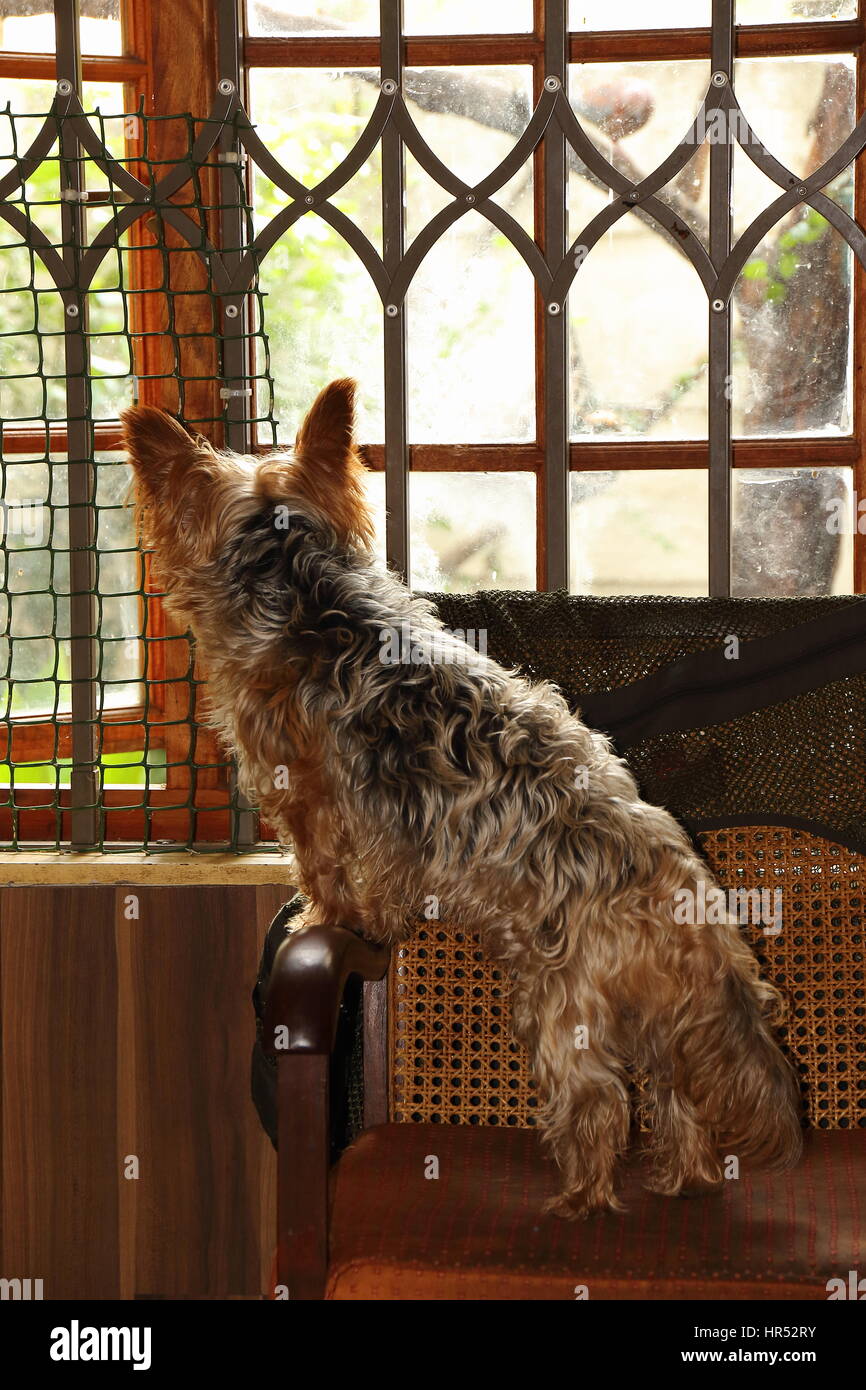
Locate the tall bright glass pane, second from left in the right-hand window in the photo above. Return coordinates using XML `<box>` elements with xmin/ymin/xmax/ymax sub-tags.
<box><xmin>405</xmin><ymin>67</ymin><xmax>535</xmax><ymax>443</ymax></box>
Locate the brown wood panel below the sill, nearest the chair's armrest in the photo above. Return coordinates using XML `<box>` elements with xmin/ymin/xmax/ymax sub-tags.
<box><xmin>123</xmin><ymin>887</ymin><xmax>268</xmax><ymax>1298</ymax></box>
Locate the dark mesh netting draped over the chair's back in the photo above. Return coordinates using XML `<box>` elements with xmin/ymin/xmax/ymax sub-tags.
<box><xmin>435</xmin><ymin>592</ymin><xmax>866</xmax><ymax>849</ymax></box>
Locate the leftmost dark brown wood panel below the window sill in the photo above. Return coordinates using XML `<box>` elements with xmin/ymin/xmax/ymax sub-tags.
<box><xmin>0</xmin><ymin>888</ymin><xmax>120</xmax><ymax>1298</ymax></box>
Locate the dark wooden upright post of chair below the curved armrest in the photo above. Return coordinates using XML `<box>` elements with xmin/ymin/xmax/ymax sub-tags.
<box><xmin>275</xmin><ymin>1052</ymin><xmax>328</xmax><ymax>1300</ymax></box>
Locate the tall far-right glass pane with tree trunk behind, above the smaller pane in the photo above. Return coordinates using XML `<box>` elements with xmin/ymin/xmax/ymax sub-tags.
<box><xmin>731</xmin><ymin>56</ymin><xmax>855</xmax><ymax>436</ymax></box>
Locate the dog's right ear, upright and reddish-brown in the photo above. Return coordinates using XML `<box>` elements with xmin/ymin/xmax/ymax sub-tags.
<box><xmin>283</xmin><ymin>378</ymin><xmax>373</xmax><ymax>545</ymax></box>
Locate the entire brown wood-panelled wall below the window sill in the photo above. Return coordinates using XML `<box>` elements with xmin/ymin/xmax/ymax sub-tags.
<box><xmin>0</xmin><ymin>884</ymin><xmax>291</xmax><ymax>1298</ymax></box>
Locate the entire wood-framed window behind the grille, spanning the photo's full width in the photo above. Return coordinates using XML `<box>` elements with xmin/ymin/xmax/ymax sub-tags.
<box><xmin>0</xmin><ymin>0</ymin><xmax>866</xmax><ymax>848</ymax></box>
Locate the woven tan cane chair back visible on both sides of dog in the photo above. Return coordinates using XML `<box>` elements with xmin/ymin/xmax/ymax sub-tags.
<box><xmin>388</xmin><ymin>826</ymin><xmax>866</xmax><ymax>1129</ymax></box>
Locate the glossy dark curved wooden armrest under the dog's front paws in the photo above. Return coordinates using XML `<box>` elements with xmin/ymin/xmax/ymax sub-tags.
<box><xmin>261</xmin><ymin>924</ymin><xmax>391</xmax><ymax>1056</ymax></box>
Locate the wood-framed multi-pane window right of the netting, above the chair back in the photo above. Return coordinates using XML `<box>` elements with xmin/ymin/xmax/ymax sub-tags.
<box><xmin>246</xmin><ymin>0</ymin><xmax>863</xmax><ymax>596</ymax></box>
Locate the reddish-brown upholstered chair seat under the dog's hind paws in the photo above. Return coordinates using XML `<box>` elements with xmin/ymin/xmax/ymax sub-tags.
<box><xmin>327</xmin><ymin>1125</ymin><xmax>866</xmax><ymax>1301</ymax></box>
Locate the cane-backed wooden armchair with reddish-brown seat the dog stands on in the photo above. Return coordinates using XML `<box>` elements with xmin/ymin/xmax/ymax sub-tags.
<box><xmin>261</xmin><ymin>606</ymin><xmax>866</xmax><ymax>1300</ymax></box>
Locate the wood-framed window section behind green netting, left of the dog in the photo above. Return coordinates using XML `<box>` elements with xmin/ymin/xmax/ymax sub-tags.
<box><xmin>0</xmin><ymin>0</ymin><xmax>243</xmax><ymax>848</ymax></box>
